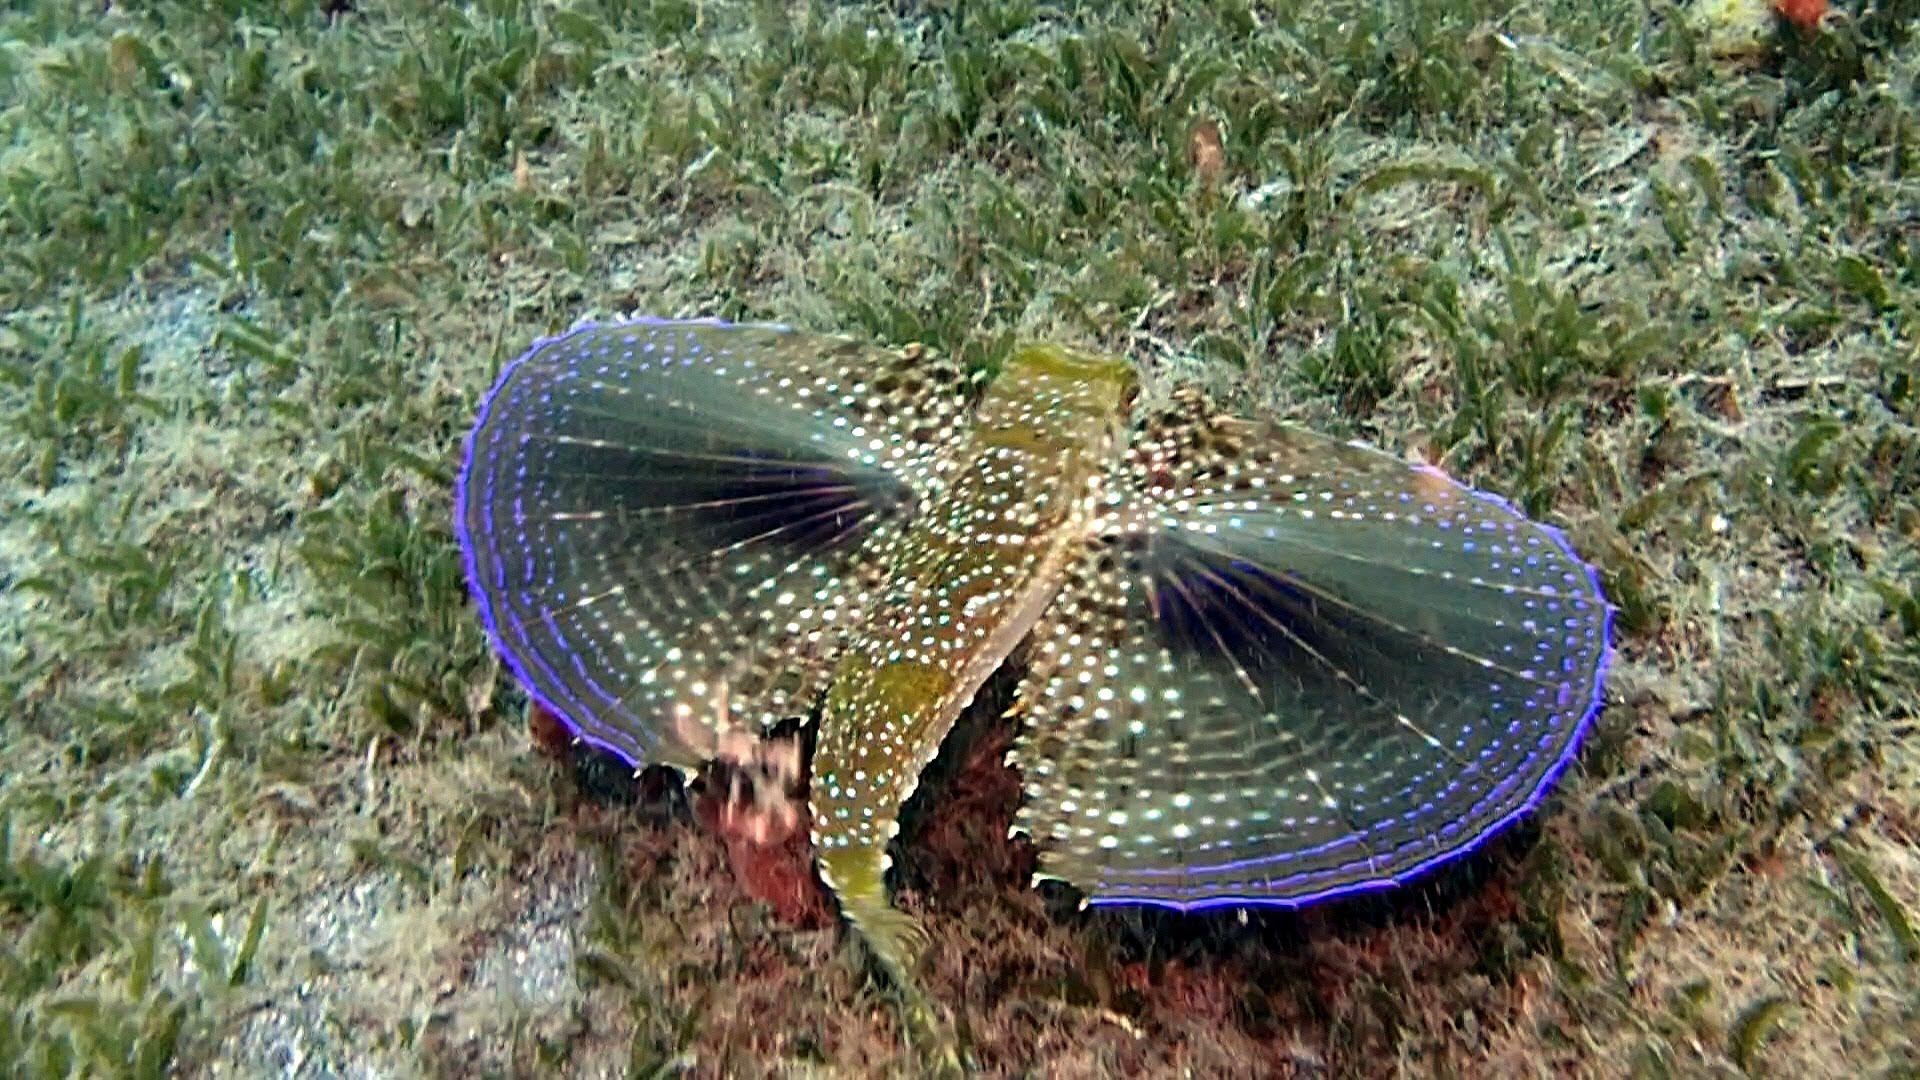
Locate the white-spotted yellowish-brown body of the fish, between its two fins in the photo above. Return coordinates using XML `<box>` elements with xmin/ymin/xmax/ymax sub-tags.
<box><xmin>812</xmin><ymin>346</ymin><xmax>1135</xmax><ymax>978</ymax></box>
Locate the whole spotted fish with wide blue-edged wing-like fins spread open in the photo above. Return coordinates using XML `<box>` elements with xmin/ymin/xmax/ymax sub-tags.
<box><xmin>453</xmin><ymin>317</ymin><xmax>1615</xmax><ymax>1045</ymax></box>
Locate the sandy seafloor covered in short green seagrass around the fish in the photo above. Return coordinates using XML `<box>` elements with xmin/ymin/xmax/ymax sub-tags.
<box><xmin>0</xmin><ymin>0</ymin><xmax>1920</xmax><ymax>1076</ymax></box>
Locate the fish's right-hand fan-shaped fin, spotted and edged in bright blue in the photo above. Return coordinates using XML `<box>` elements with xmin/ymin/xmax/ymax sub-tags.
<box><xmin>1016</xmin><ymin>411</ymin><xmax>1611</xmax><ymax>907</ymax></box>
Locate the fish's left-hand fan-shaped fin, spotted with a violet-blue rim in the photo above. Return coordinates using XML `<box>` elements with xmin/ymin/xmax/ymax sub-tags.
<box><xmin>455</xmin><ymin>319</ymin><xmax>968</xmax><ymax>767</ymax></box>
